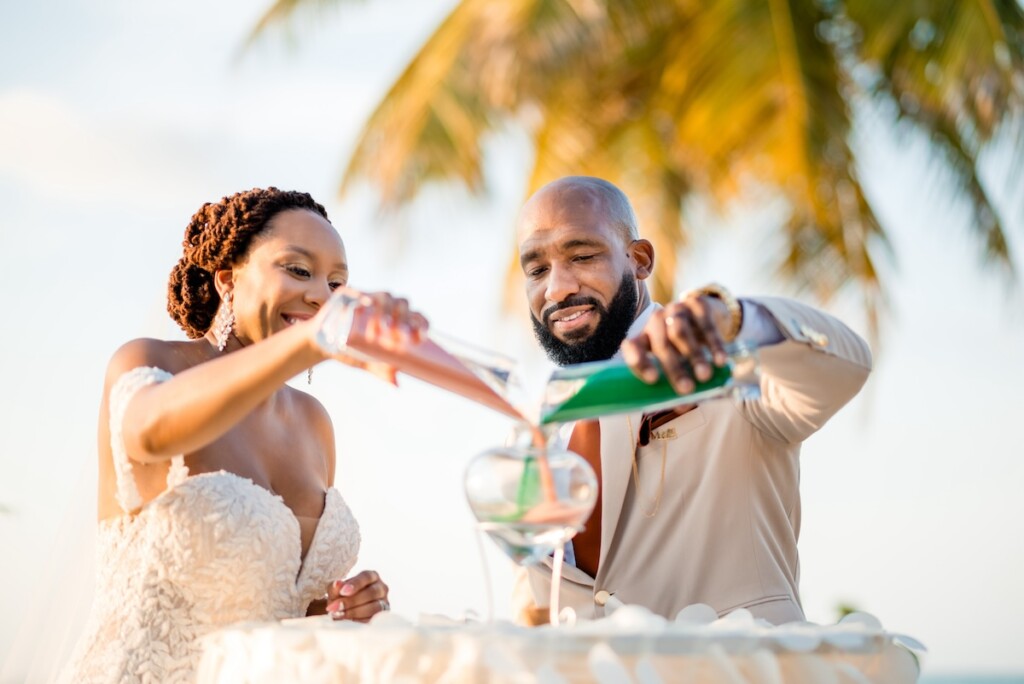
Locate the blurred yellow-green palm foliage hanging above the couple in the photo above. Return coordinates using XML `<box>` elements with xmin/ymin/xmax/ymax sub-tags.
<box><xmin>247</xmin><ymin>0</ymin><xmax>1024</xmax><ymax>325</ymax></box>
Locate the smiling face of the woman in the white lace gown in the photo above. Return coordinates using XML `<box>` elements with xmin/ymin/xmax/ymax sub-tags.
<box><xmin>231</xmin><ymin>209</ymin><xmax>348</xmax><ymax>344</ymax></box>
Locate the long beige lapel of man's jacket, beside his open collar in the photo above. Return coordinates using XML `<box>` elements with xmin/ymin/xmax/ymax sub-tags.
<box><xmin>598</xmin><ymin>413</ymin><xmax>643</xmax><ymax>575</ymax></box>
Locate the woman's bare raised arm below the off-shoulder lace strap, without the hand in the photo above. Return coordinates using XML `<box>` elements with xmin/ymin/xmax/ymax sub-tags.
<box><xmin>108</xmin><ymin>318</ymin><xmax>327</xmax><ymax>463</ymax></box>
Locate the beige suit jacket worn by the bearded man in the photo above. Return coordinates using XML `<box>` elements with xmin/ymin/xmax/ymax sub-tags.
<box><xmin>513</xmin><ymin>298</ymin><xmax>871</xmax><ymax>624</ymax></box>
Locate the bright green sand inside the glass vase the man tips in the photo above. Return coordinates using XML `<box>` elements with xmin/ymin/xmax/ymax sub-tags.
<box><xmin>541</xmin><ymin>361</ymin><xmax>732</xmax><ymax>425</ymax></box>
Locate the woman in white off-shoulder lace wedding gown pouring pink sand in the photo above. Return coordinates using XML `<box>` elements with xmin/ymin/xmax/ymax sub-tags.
<box><xmin>60</xmin><ymin>187</ymin><xmax>426</xmax><ymax>682</ymax></box>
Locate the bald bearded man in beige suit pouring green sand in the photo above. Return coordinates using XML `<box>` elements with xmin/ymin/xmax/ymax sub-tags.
<box><xmin>514</xmin><ymin>177</ymin><xmax>871</xmax><ymax>624</ymax></box>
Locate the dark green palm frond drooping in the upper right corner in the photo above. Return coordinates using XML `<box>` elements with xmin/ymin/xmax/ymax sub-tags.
<box><xmin>850</xmin><ymin>0</ymin><xmax>1024</xmax><ymax>280</ymax></box>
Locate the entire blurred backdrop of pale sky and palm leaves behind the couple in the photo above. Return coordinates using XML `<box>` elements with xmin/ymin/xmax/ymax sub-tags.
<box><xmin>0</xmin><ymin>0</ymin><xmax>1024</xmax><ymax>682</ymax></box>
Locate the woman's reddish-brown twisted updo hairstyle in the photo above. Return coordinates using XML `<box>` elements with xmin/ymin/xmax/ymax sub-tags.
<box><xmin>167</xmin><ymin>187</ymin><xmax>327</xmax><ymax>339</ymax></box>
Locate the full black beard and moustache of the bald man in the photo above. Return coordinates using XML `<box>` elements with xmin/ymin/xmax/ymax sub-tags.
<box><xmin>529</xmin><ymin>271</ymin><xmax>639</xmax><ymax>366</ymax></box>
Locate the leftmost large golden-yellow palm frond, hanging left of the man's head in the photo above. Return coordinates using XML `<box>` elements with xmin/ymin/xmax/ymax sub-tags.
<box><xmin>342</xmin><ymin>0</ymin><xmax>614</xmax><ymax>206</ymax></box>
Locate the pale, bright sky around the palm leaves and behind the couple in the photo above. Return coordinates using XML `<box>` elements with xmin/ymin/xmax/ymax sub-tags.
<box><xmin>0</xmin><ymin>0</ymin><xmax>1024</xmax><ymax>673</ymax></box>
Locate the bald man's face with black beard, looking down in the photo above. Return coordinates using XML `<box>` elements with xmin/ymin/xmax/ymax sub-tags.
<box><xmin>519</xmin><ymin>190</ymin><xmax>639</xmax><ymax>365</ymax></box>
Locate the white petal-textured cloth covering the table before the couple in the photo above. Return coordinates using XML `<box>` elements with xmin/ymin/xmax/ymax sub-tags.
<box><xmin>198</xmin><ymin>606</ymin><xmax>921</xmax><ymax>684</ymax></box>
